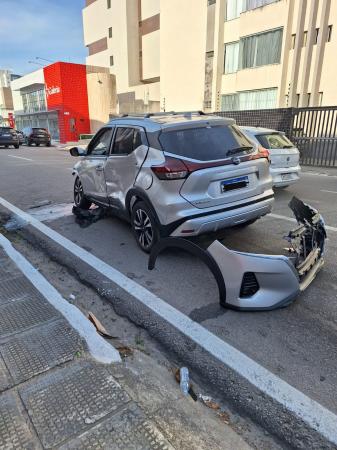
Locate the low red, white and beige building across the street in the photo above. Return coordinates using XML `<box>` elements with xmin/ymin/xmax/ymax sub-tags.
<box><xmin>12</xmin><ymin>62</ymin><xmax>116</xmax><ymax>143</ymax></box>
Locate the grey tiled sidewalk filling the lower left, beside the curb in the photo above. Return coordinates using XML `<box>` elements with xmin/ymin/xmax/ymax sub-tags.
<box><xmin>0</xmin><ymin>236</ymin><xmax>250</xmax><ymax>450</ymax></box>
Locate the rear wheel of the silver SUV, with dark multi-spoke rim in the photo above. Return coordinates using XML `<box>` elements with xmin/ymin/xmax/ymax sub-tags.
<box><xmin>131</xmin><ymin>201</ymin><xmax>160</xmax><ymax>253</ymax></box>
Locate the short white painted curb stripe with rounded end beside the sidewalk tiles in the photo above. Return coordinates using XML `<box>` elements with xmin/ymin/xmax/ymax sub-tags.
<box><xmin>0</xmin><ymin>230</ymin><xmax>121</xmax><ymax>364</ymax></box>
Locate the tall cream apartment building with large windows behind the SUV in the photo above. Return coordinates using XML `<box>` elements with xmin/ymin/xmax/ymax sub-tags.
<box><xmin>83</xmin><ymin>0</ymin><xmax>337</xmax><ymax>113</ymax></box>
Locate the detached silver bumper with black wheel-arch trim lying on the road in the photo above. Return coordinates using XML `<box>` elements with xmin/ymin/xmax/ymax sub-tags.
<box><xmin>149</xmin><ymin>197</ymin><xmax>326</xmax><ymax>311</ymax></box>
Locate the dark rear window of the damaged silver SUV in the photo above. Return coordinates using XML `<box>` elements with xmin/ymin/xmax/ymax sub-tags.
<box><xmin>159</xmin><ymin>125</ymin><xmax>253</xmax><ymax>161</ymax></box>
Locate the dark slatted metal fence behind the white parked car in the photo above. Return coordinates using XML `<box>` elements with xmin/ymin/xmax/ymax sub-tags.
<box><xmin>215</xmin><ymin>106</ymin><xmax>337</xmax><ymax>167</ymax></box>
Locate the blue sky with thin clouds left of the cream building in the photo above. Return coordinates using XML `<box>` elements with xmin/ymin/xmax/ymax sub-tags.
<box><xmin>0</xmin><ymin>0</ymin><xmax>87</xmax><ymax>75</ymax></box>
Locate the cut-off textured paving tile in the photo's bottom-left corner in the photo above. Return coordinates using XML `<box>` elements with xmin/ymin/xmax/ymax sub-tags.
<box><xmin>0</xmin><ymin>392</ymin><xmax>39</xmax><ymax>450</ymax></box>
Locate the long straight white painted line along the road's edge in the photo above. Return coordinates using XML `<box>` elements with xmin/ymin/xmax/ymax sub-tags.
<box><xmin>0</xmin><ymin>197</ymin><xmax>337</xmax><ymax>445</ymax></box>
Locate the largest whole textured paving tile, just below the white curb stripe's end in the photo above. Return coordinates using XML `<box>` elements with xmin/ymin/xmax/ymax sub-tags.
<box><xmin>19</xmin><ymin>362</ymin><xmax>130</xmax><ymax>448</ymax></box>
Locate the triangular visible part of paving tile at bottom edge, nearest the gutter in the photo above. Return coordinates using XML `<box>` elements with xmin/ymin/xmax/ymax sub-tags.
<box><xmin>60</xmin><ymin>403</ymin><xmax>173</xmax><ymax>450</ymax></box>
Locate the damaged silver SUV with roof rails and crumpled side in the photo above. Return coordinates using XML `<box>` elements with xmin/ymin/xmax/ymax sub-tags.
<box><xmin>70</xmin><ymin>112</ymin><xmax>274</xmax><ymax>252</ymax></box>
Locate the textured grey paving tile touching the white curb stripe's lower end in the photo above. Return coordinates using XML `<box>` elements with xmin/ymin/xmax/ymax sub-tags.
<box><xmin>0</xmin><ymin>320</ymin><xmax>84</xmax><ymax>384</ymax></box>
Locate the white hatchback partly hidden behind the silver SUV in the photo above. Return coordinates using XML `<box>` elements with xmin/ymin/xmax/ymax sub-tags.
<box><xmin>240</xmin><ymin>127</ymin><xmax>301</xmax><ymax>188</ymax></box>
